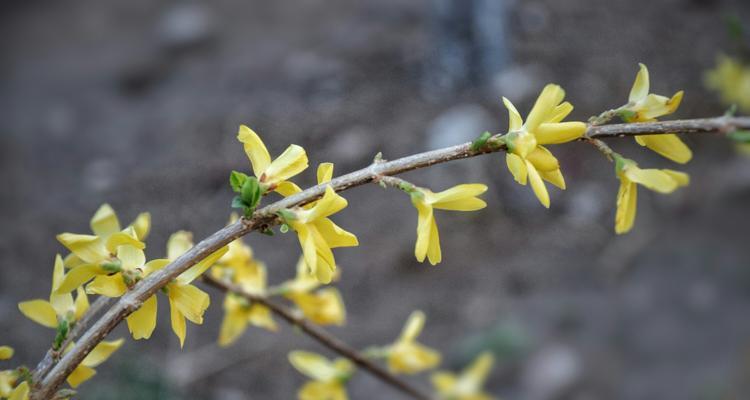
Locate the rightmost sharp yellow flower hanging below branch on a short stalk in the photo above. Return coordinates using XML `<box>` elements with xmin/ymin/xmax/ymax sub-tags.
<box><xmin>615</xmin><ymin>157</ymin><xmax>690</xmax><ymax>234</ymax></box>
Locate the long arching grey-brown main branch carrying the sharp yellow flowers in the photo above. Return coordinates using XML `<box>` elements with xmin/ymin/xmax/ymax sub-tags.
<box><xmin>32</xmin><ymin>117</ymin><xmax>750</xmax><ymax>400</ymax></box>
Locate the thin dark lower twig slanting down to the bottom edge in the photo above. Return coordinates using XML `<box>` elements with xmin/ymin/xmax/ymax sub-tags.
<box><xmin>203</xmin><ymin>275</ymin><xmax>431</xmax><ymax>400</ymax></box>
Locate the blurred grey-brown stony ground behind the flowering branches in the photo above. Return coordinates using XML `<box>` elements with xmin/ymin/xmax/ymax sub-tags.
<box><xmin>0</xmin><ymin>0</ymin><xmax>750</xmax><ymax>400</ymax></box>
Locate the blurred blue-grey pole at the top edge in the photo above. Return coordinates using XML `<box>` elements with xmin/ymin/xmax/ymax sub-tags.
<box><xmin>425</xmin><ymin>0</ymin><xmax>510</xmax><ymax>97</ymax></box>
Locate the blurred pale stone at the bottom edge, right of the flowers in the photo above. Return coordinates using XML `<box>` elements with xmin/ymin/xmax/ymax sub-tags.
<box><xmin>522</xmin><ymin>344</ymin><xmax>583</xmax><ymax>400</ymax></box>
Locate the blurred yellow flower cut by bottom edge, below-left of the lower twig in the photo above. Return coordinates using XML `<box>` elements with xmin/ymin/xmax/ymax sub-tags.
<box><xmin>289</xmin><ymin>351</ymin><xmax>354</xmax><ymax>400</ymax></box>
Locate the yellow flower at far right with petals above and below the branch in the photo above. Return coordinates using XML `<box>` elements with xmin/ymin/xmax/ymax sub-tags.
<box><xmin>619</xmin><ymin>64</ymin><xmax>693</xmax><ymax>164</ymax></box>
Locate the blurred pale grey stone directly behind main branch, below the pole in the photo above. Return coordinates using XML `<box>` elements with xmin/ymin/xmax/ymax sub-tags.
<box><xmin>427</xmin><ymin>104</ymin><xmax>496</xmax><ymax>149</ymax></box>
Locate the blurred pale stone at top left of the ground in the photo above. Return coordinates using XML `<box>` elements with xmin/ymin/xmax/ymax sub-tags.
<box><xmin>158</xmin><ymin>3</ymin><xmax>216</xmax><ymax>50</ymax></box>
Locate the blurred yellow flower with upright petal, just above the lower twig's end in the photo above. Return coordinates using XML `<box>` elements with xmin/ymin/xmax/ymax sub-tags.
<box><xmin>386</xmin><ymin>311</ymin><xmax>441</xmax><ymax>374</ymax></box>
